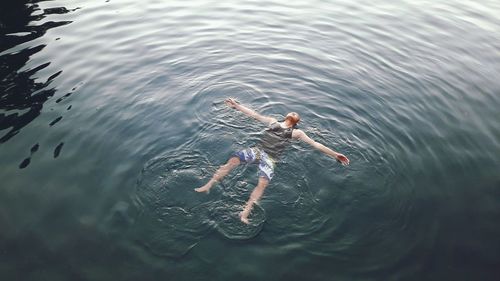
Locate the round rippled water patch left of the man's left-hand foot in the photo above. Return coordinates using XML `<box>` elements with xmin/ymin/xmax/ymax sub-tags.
<box><xmin>133</xmin><ymin>153</ymin><xmax>210</xmax><ymax>256</ymax></box>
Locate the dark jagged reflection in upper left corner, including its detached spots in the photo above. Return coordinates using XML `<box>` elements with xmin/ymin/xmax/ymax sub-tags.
<box><xmin>0</xmin><ymin>1</ymin><xmax>71</xmax><ymax>169</ymax></box>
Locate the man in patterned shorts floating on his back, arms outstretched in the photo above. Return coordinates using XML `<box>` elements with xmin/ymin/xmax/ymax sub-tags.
<box><xmin>195</xmin><ymin>98</ymin><xmax>349</xmax><ymax>224</ymax></box>
